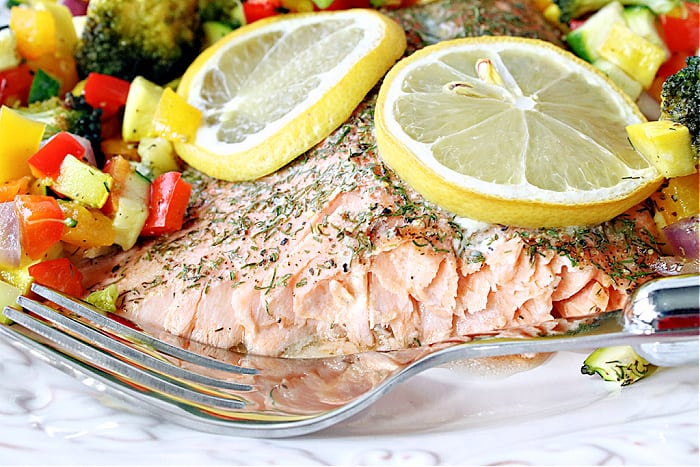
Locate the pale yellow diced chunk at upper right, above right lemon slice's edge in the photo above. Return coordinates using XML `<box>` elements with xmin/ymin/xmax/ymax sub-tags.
<box><xmin>600</xmin><ymin>23</ymin><xmax>666</xmax><ymax>89</ymax></box>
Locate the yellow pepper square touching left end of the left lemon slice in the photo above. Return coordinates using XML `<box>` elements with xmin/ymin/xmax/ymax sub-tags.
<box><xmin>152</xmin><ymin>88</ymin><xmax>202</xmax><ymax>142</ymax></box>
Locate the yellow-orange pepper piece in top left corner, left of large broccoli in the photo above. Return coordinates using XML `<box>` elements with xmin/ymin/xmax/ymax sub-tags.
<box><xmin>10</xmin><ymin>6</ymin><xmax>58</xmax><ymax>60</ymax></box>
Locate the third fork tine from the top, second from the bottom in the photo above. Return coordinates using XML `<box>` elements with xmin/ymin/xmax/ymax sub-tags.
<box><xmin>1</xmin><ymin>307</ymin><xmax>246</xmax><ymax>410</ymax></box>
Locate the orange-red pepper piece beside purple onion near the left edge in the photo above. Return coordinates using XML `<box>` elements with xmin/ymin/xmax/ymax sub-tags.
<box><xmin>15</xmin><ymin>195</ymin><xmax>65</xmax><ymax>259</ymax></box>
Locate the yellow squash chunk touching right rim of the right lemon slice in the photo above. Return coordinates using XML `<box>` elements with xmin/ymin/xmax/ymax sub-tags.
<box><xmin>626</xmin><ymin>120</ymin><xmax>695</xmax><ymax>178</ymax></box>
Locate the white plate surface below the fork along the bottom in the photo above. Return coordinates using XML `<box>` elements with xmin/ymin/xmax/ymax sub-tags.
<box><xmin>0</xmin><ymin>332</ymin><xmax>700</xmax><ymax>466</ymax></box>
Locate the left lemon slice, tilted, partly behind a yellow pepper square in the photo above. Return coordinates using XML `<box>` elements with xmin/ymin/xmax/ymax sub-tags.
<box><xmin>175</xmin><ymin>9</ymin><xmax>406</xmax><ymax>181</ymax></box>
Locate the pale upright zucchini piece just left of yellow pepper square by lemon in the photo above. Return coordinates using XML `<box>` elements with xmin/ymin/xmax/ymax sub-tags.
<box><xmin>122</xmin><ymin>76</ymin><xmax>163</xmax><ymax>142</ymax></box>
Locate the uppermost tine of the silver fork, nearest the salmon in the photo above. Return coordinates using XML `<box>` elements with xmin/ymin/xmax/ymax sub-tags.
<box><xmin>31</xmin><ymin>283</ymin><xmax>258</xmax><ymax>375</ymax></box>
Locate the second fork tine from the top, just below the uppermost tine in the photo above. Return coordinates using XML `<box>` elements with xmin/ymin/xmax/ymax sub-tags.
<box><xmin>10</xmin><ymin>296</ymin><xmax>252</xmax><ymax>391</ymax></box>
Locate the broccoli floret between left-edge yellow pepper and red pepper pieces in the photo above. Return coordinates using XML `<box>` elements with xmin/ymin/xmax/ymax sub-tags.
<box><xmin>15</xmin><ymin>93</ymin><xmax>102</xmax><ymax>162</ymax></box>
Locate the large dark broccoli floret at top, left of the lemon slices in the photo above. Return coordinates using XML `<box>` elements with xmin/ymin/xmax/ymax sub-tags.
<box><xmin>75</xmin><ymin>0</ymin><xmax>199</xmax><ymax>84</ymax></box>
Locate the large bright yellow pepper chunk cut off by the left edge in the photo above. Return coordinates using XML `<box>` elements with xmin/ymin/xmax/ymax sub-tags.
<box><xmin>0</xmin><ymin>106</ymin><xmax>45</xmax><ymax>183</ymax></box>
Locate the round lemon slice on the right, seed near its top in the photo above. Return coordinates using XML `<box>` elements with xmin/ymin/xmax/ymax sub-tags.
<box><xmin>375</xmin><ymin>37</ymin><xmax>662</xmax><ymax>227</ymax></box>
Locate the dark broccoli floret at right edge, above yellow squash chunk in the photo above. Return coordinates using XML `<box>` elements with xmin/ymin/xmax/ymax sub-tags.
<box><xmin>659</xmin><ymin>55</ymin><xmax>700</xmax><ymax>160</ymax></box>
